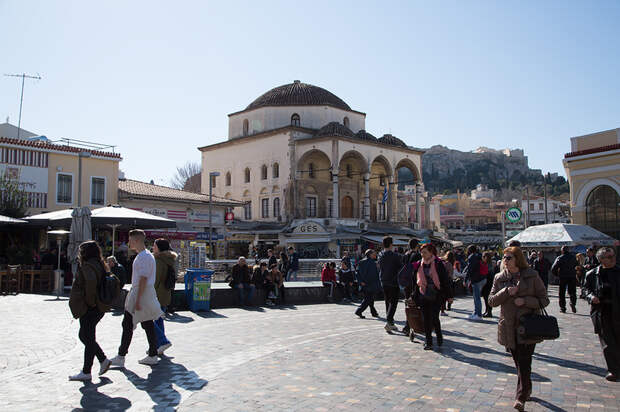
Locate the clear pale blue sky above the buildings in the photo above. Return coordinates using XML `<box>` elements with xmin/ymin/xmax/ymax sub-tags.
<box><xmin>0</xmin><ymin>0</ymin><xmax>620</xmax><ymax>183</ymax></box>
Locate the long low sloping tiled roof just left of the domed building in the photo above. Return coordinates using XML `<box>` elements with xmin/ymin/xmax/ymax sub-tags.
<box><xmin>118</xmin><ymin>179</ymin><xmax>243</xmax><ymax>207</ymax></box>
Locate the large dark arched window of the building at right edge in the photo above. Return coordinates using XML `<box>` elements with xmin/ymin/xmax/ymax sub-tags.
<box><xmin>586</xmin><ymin>185</ymin><xmax>620</xmax><ymax>239</ymax></box>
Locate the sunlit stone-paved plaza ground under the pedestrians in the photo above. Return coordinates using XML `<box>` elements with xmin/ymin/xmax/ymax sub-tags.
<box><xmin>0</xmin><ymin>289</ymin><xmax>620</xmax><ymax>411</ymax></box>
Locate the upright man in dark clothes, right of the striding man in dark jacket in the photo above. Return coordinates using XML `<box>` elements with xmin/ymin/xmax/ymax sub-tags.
<box><xmin>379</xmin><ymin>236</ymin><xmax>403</xmax><ymax>333</ymax></box>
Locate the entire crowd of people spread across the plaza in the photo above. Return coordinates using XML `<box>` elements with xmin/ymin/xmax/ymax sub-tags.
<box><xmin>69</xmin><ymin>230</ymin><xmax>620</xmax><ymax>410</ymax></box>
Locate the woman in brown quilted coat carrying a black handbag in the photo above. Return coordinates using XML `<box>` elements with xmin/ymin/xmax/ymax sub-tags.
<box><xmin>489</xmin><ymin>246</ymin><xmax>549</xmax><ymax>411</ymax></box>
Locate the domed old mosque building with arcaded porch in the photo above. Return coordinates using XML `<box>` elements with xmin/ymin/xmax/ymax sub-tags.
<box><xmin>199</xmin><ymin>80</ymin><xmax>423</xmax><ymax>254</ymax></box>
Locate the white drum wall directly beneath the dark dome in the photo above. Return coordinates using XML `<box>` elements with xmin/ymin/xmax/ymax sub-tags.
<box><xmin>228</xmin><ymin>106</ymin><xmax>366</xmax><ymax>139</ymax></box>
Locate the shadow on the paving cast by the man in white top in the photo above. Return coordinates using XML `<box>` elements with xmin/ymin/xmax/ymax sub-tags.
<box><xmin>121</xmin><ymin>356</ymin><xmax>208</xmax><ymax>410</ymax></box>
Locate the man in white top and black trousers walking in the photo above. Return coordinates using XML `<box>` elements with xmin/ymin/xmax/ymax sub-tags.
<box><xmin>112</xmin><ymin>229</ymin><xmax>161</xmax><ymax>367</ymax></box>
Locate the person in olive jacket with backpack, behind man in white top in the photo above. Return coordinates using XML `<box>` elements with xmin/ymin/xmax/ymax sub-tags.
<box><xmin>153</xmin><ymin>238</ymin><xmax>178</xmax><ymax>355</ymax></box>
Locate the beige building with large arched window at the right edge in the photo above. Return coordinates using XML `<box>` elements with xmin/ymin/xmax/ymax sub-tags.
<box><xmin>564</xmin><ymin>129</ymin><xmax>620</xmax><ymax>239</ymax></box>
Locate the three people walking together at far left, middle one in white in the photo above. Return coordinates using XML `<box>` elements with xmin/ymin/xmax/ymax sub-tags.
<box><xmin>69</xmin><ymin>230</ymin><xmax>177</xmax><ymax>381</ymax></box>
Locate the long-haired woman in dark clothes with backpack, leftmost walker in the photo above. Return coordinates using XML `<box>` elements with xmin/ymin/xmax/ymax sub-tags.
<box><xmin>69</xmin><ymin>240</ymin><xmax>111</xmax><ymax>381</ymax></box>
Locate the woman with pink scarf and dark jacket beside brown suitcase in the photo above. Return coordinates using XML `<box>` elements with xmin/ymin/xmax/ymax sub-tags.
<box><xmin>413</xmin><ymin>243</ymin><xmax>453</xmax><ymax>350</ymax></box>
